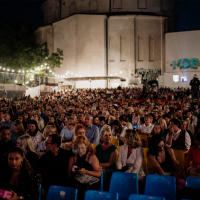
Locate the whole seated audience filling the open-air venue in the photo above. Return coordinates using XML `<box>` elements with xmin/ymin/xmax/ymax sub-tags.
<box><xmin>0</xmin><ymin>84</ymin><xmax>200</xmax><ymax>200</ymax></box>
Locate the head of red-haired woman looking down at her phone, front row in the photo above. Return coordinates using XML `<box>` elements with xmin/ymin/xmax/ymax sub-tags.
<box><xmin>74</xmin><ymin>135</ymin><xmax>90</xmax><ymax>156</ymax></box>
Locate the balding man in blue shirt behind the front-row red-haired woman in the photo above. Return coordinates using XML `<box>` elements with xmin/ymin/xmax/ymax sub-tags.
<box><xmin>85</xmin><ymin>115</ymin><xmax>99</xmax><ymax>144</ymax></box>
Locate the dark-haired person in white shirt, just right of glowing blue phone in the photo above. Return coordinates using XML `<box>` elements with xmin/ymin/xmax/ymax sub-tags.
<box><xmin>138</xmin><ymin>114</ymin><xmax>154</xmax><ymax>136</ymax></box>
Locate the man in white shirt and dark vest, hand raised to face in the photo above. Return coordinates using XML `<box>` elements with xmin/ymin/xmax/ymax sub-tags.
<box><xmin>166</xmin><ymin>118</ymin><xmax>191</xmax><ymax>153</ymax></box>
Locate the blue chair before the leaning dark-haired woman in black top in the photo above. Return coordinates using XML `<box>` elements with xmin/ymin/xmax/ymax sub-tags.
<box><xmin>144</xmin><ymin>174</ymin><xmax>176</xmax><ymax>200</ymax></box>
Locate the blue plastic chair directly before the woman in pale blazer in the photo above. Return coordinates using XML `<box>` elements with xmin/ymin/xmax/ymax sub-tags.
<box><xmin>109</xmin><ymin>172</ymin><xmax>138</xmax><ymax>200</ymax></box>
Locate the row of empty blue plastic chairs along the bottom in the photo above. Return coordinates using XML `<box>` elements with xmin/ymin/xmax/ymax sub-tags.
<box><xmin>47</xmin><ymin>172</ymin><xmax>200</xmax><ymax>200</ymax></box>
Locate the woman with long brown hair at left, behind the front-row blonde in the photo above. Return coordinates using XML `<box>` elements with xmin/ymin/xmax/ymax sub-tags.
<box><xmin>10</xmin><ymin>119</ymin><xmax>25</xmax><ymax>144</ymax></box>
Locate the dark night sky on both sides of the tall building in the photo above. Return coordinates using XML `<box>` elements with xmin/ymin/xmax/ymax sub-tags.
<box><xmin>0</xmin><ymin>0</ymin><xmax>200</xmax><ymax>31</ymax></box>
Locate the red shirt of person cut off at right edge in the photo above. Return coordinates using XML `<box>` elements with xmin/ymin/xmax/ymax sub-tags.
<box><xmin>185</xmin><ymin>146</ymin><xmax>200</xmax><ymax>169</ymax></box>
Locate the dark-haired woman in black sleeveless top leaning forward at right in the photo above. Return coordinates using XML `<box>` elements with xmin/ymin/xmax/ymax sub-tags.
<box><xmin>147</xmin><ymin>135</ymin><xmax>185</xmax><ymax>177</ymax></box>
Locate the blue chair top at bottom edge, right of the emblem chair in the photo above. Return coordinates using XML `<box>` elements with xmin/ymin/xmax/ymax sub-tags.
<box><xmin>85</xmin><ymin>190</ymin><xmax>118</xmax><ymax>200</ymax></box>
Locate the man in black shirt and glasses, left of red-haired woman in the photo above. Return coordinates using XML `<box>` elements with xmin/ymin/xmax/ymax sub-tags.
<box><xmin>39</xmin><ymin>134</ymin><xmax>74</xmax><ymax>198</ymax></box>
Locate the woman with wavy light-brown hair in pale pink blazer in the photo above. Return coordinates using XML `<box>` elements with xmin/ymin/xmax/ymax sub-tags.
<box><xmin>117</xmin><ymin>129</ymin><xmax>145</xmax><ymax>190</ymax></box>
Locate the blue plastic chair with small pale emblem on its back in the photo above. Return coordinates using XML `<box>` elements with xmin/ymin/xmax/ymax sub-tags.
<box><xmin>46</xmin><ymin>185</ymin><xmax>78</xmax><ymax>200</ymax></box>
